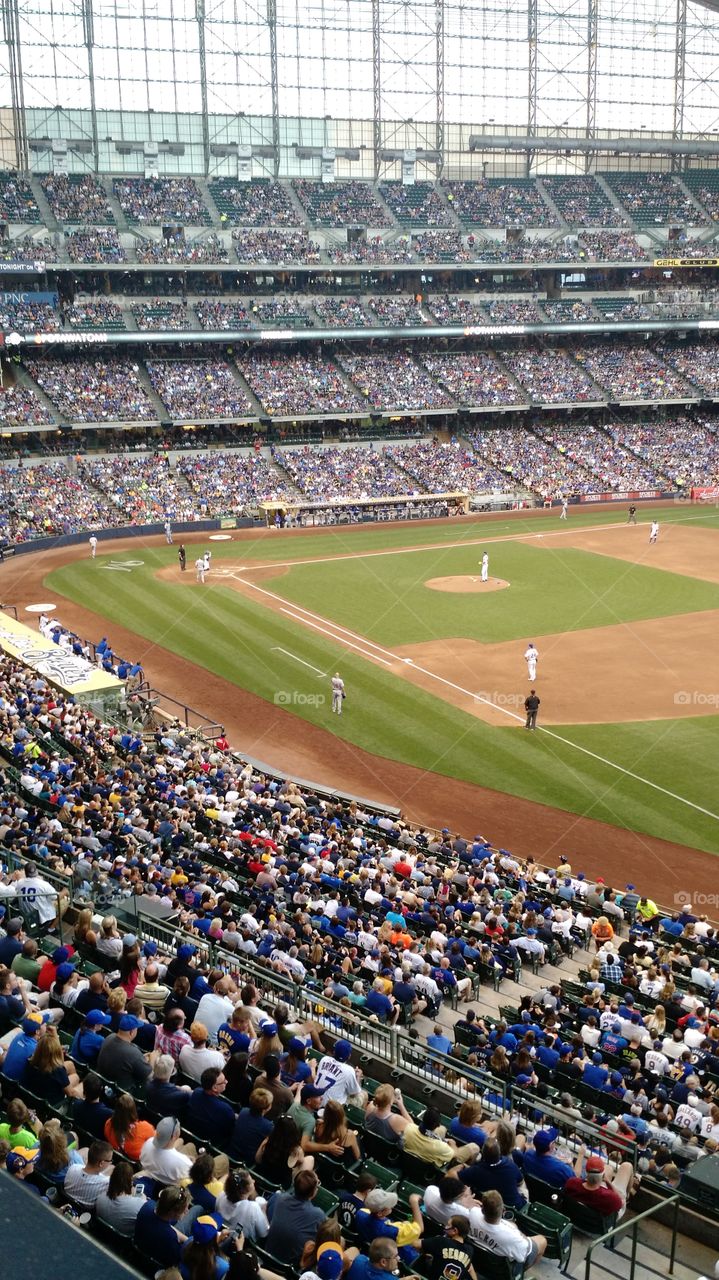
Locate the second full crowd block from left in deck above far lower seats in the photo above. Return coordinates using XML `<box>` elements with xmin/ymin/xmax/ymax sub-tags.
<box><xmin>146</xmin><ymin>356</ymin><xmax>252</xmax><ymax>421</ymax></box>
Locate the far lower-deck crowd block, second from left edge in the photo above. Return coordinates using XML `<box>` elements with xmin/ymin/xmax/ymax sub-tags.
<box><xmin>78</xmin><ymin>453</ymin><xmax>198</xmax><ymax>525</ymax></box>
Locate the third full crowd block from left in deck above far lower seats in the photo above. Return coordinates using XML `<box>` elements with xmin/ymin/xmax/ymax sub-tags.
<box><xmin>238</xmin><ymin>351</ymin><xmax>363</xmax><ymax>417</ymax></box>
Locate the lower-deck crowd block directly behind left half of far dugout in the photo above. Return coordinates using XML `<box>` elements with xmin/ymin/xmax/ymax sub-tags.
<box><xmin>273</xmin><ymin>443</ymin><xmax>412</xmax><ymax>502</ymax></box>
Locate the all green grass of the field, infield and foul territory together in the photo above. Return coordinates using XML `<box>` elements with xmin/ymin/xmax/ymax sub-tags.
<box><xmin>46</xmin><ymin>507</ymin><xmax>719</xmax><ymax>852</ymax></box>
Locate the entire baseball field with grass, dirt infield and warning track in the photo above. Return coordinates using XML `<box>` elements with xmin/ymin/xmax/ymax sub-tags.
<box><xmin>3</xmin><ymin>504</ymin><xmax>719</xmax><ymax>887</ymax></box>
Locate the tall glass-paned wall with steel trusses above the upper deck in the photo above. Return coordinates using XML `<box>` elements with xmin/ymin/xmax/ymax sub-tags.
<box><xmin>0</xmin><ymin>0</ymin><xmax>719</xmax><ymax>178</ymax></box>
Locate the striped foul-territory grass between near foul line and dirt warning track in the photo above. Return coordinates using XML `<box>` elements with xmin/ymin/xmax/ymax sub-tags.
<box><xmin>49</xmin><ymin>547</ymin><xmax>715</xmax><ymax>850</ymax></box>
